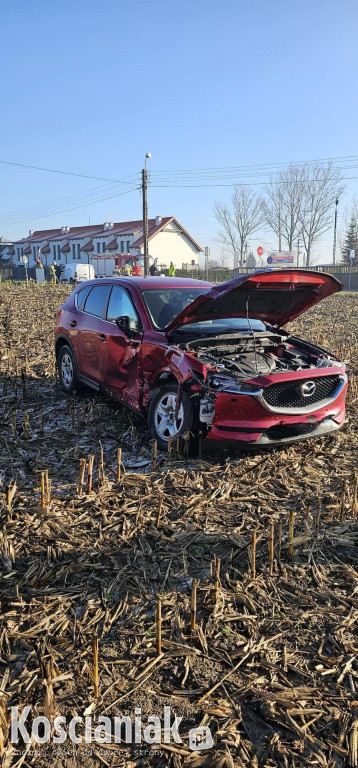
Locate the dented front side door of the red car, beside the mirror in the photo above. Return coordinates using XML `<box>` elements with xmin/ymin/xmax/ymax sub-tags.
<box><xmin>103</xmin><ymin>285</ymin><xmax>142</xmax><ymax>409</ymax></box>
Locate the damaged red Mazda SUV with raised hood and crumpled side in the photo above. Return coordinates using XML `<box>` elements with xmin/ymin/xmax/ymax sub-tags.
<box><xmin>55</xmin><ymin>269</ymin><xmax>347</xmax><ymax>449</ymax></box>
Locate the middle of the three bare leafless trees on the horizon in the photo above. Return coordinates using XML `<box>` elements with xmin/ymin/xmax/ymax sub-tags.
<box><xmin>262</xmin><ymin>165</ymin><xmax>303</xmax><ymax>251</ymax></box>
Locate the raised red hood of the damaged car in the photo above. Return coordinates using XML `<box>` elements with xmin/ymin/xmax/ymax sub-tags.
<box><xmin>165</xmin><ymin>269</ymin><xmax>343</xmax><ymax>332</ymax></box>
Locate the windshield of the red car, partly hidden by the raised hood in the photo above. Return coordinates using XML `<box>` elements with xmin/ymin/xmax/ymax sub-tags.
<box><xmin>142</xmin><ymin>288</ymin><xmax>265</xmax><ymax>336</ymax></box>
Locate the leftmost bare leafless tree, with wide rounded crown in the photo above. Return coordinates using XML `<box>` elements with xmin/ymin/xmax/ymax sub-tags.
<box><xmin>214</xmin><ymin>184</ymin><xmax>263</xmax><ymax>267</ymax></box>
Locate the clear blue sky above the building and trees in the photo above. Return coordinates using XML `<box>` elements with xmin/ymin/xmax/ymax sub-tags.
<box><xmin>0</xmin><ymin>0</ymin><xmax>358</xmax><ymax>260</ymax></box>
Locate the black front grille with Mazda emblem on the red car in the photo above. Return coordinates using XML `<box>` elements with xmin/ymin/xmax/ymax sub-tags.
<box><xmin>263</xmin><ymin>376</ymin><xmax>340</xmax><ymax>408</ymax></box>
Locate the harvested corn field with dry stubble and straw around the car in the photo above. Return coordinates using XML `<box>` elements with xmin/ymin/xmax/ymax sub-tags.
<box><xmin>0</xmin><ymin>285</ymin><xmax>358</xmax><ymax>768</ymax></box>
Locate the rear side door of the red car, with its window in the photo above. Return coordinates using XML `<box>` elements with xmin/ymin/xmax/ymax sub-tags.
<box><xmin>79</xmin><ymin>283</ymin><xmax>112</xmax><ymax>383</ymax></box>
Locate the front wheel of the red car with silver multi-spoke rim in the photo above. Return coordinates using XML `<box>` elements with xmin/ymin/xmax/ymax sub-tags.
<box><xmin>148</xmin><ymin>382</ymin><xmax>199</xmax><ymax>455</ymax></box>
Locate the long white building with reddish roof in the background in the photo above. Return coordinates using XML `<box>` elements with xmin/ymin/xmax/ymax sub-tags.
<box><xmin>11</xmin><ymin>216</ymin><xmax>203</xmax><ymax>269</ymax></box>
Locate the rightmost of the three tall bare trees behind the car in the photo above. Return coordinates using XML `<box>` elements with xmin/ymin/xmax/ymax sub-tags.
<box><xmin>298</xmin><ymin>162</ymin><xmax>344</xmax><ymax>267</ymax></box>
